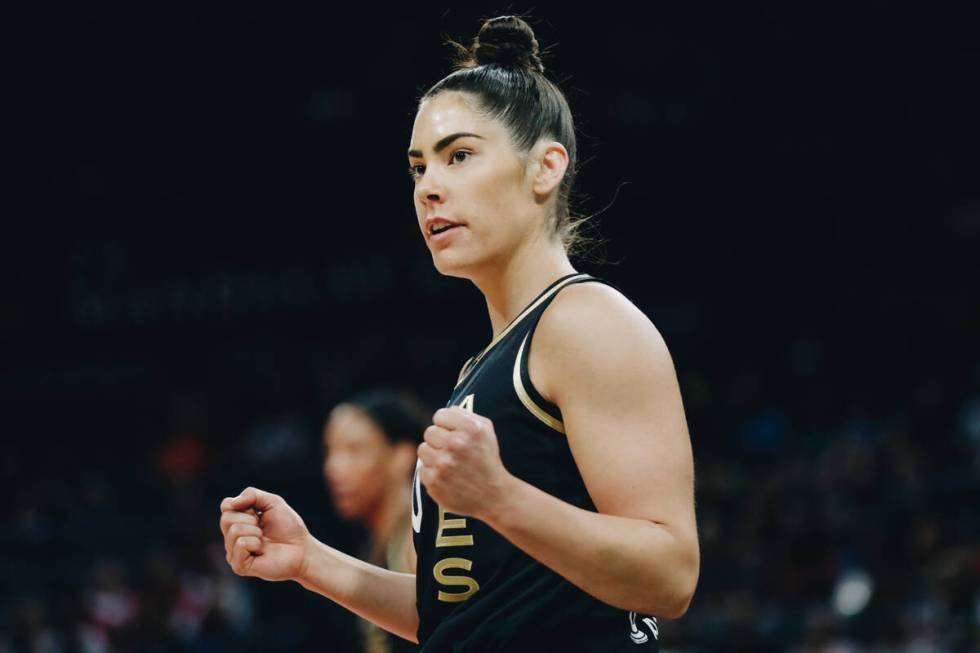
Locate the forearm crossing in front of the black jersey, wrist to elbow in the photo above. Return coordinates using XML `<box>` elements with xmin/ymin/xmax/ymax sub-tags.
<box><xmin>485</xmin><ymin>477</ymin><xmax>698</xmax><ymax>618</ymax></box>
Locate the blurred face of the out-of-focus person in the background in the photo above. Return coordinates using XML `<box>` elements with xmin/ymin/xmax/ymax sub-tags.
<box><xmin>323</xmin><ymin>404</ymin><xmax>392</xmax><ymax>519</ymax></box>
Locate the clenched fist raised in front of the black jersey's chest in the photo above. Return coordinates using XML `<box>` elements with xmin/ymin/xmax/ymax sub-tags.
<box><xmin>418</xmin><ymin>406</ymin><xmax>511</xmax><ymax>519</ymax></box>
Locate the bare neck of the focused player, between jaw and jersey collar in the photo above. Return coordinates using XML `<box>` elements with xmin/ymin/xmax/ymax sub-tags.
<box><xmin>473</xmin><ymin>233</ymin><xmax>576</xmax><ymax>338</ymax></box>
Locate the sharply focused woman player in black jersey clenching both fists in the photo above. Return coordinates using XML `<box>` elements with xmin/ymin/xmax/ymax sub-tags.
<box><xmin>220</xmin><ymin>16</ymin><xmax>700</xmax><ymax>653</ymax></box>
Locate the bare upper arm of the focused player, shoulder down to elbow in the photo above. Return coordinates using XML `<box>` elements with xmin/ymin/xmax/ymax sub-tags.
<box><xmin>531</xmin><ymin>284</ymin><xmax>697</xmax><ymax>551</ymax></box>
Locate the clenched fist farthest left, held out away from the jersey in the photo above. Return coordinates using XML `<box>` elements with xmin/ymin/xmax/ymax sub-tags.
<box><xmin>220</xmin><ymin>487</ymin><xmax>312</xmax><ymax>580</ymax></box>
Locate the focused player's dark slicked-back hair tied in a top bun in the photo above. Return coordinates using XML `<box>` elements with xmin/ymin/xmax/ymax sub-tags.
<box><xmin>419</xmin><ymin>16</ymin><xmax>597</xmax><ymax>256</ymax></box>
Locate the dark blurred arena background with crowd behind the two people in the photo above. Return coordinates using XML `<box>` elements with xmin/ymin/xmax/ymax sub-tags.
<box><xmin>0</xmin><ymin>5</ymin><xmax>980</xmax><ymax>653</ymax></box>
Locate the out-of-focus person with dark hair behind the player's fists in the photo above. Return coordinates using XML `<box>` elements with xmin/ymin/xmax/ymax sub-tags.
<box><xmin>323</xmin><ymin>389</ymin><xmax>431</xmax><ymax>653</ymax></box>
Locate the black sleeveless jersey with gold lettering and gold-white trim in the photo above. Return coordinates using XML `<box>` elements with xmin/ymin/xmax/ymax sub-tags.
<box><xmin>412</xmin><ymin>273</ymin><xmax>659</xmax><ymax>653</ymax></box>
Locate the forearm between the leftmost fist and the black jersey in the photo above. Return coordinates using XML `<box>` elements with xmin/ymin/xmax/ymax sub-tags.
<box><xmin>296</xmin><ymin>541</ymin><xmax>419</xmax><ymax>643</ymax></box>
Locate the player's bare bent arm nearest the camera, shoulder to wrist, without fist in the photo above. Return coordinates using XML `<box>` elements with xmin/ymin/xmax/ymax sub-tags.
<box><xmin>487</xmin><ymin>284</ymin><xmax>700</xmax><ymax>618</ymax></box>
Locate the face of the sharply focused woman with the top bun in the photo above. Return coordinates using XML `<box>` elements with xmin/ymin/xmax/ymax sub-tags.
<box><xmin>408</xmin><ymin>91</ymin><xmax>545</xmax><ymax>277</ymax></box>
